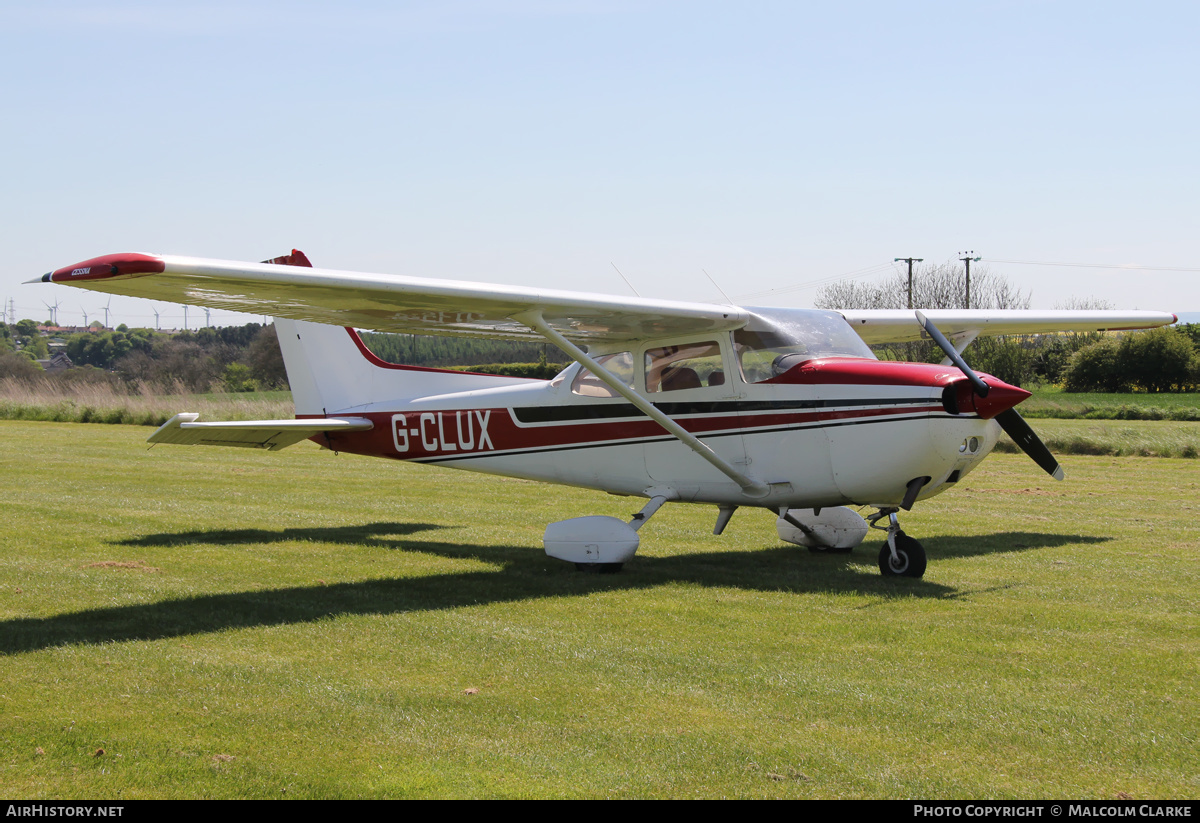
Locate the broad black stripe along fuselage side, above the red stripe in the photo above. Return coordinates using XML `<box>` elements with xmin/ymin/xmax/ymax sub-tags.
<box><xmin>512</xmin><ymin>397</ymin><xmax>941</xmax><ymax>423</ymax></box>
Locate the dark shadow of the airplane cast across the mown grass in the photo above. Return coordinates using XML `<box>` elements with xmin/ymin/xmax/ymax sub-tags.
<box><xmin>0</xmin><ymin>523</ymin><xmax>1108</xmax><ymax>655</ymax></box>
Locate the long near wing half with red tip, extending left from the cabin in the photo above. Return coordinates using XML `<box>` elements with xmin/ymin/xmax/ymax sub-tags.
<box><xmin>41</xmin><ymin>253</ymin><xmax>749</xmax><ymax>342</ymax></box>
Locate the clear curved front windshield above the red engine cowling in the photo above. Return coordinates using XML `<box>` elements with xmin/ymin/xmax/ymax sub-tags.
<box><xmin>733</xmin><ymin>308</ymin><xmax>876</xmax><ymax>383</ymax></box>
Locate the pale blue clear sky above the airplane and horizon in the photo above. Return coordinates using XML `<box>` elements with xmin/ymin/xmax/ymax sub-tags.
<box><xmin>0</xmin><ymin>0</ymin><xmax>1200</xmax><ymax>325</ymax></box>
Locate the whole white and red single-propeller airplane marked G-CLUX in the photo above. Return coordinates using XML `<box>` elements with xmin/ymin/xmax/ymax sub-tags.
<box><xmin>30</xmin><ymin>250</ymin><xmax>1176</xmax><ymax>577</ymax></box>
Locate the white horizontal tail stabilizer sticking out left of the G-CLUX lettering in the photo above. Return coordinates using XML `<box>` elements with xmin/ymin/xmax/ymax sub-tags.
<box><xmin>148</xmin><ymin>412</ymin><xmax>374</xmax><ymax>451</ymax></box>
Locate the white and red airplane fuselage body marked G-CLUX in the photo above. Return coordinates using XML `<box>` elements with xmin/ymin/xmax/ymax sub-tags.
<box><xmin>316</xmin><ymin>355</ymin><xmax>1003</xmax><ymax>507</ymax></box>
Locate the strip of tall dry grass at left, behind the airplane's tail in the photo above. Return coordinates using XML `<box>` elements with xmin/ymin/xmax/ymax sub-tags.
<box><xmin>0</xmin><ymin>377</ymin><xmax>294</xmax><ymax>426</ymax></box>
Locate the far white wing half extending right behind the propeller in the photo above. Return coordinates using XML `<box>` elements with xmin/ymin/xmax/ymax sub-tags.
<box><xmin>840</xmin><ymin>308</ymin><xmax>1177</xmax><ymax>344</ymax></box>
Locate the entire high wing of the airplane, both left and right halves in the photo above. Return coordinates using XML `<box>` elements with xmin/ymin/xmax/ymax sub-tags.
<box><xmin>35</xmin><ymin>253</ymin><xmax>1176</xmax><ymax>346</ymax></box>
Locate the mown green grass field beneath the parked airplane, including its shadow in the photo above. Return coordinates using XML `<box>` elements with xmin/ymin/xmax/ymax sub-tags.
<box><xmin>0</xmin><ymin>421</ymin><xmax>1200</xmax><ymax>799</ymax></box>
